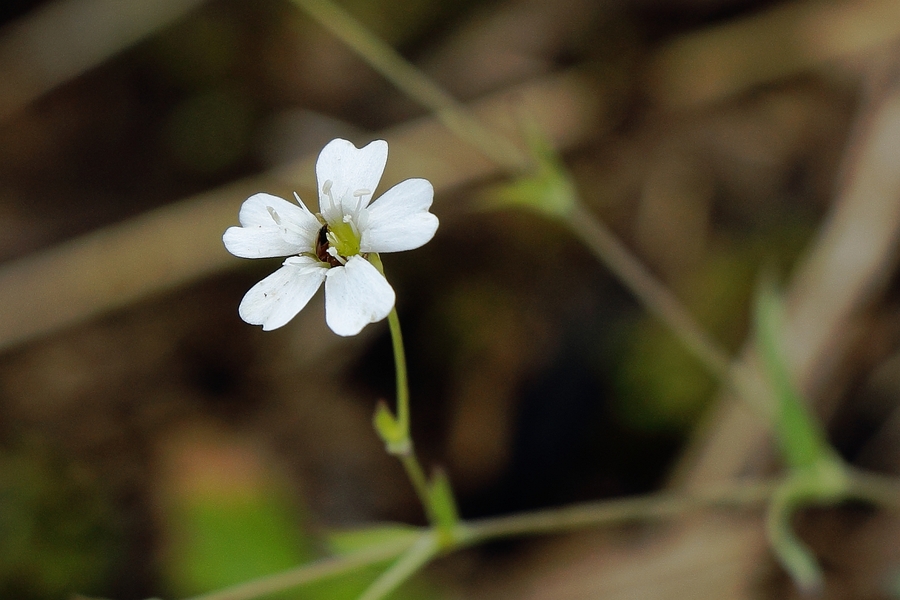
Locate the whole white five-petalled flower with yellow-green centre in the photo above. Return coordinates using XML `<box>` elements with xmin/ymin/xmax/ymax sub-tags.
<box><xmin>222</xmin><ymin>139</ymin><xmax>438</xmax><ymax>336</ymax></box>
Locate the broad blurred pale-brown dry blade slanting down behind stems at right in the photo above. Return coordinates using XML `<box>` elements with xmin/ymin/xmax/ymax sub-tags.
<box><xmin>496</xmin><ymin>59</ymin><xmax>900</xmax><ymax>599</ymax></box>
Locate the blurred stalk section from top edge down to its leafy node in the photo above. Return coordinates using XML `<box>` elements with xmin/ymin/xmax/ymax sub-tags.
<box><xmin>293</xmin><ymin>0</ymin><xmax>531</xmax><ymax>171</ymax></box>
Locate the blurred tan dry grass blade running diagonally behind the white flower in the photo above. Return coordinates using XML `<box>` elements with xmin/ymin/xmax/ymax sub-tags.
<box><xmin>0</xmin><ymin>73</ymin><xmax>605</xmax><ymax>349</ymax></box>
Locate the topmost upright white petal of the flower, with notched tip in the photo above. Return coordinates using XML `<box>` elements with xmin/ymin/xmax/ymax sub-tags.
<box><xmin>316</xmin><ymin>138</ymin><xmax>387</xmax><ymax>222</ymax></box>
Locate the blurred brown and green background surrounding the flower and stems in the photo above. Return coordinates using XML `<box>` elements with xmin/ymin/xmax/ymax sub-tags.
<box><xmin>0</xmin><ymin>0</ymin><xmax>900</xmax><ymax>600</ymax></box>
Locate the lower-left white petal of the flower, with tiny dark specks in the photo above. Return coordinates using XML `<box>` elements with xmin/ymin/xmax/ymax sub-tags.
<box><xmin>238</xmin><ymin>256</ymin><xmax>328</xmax><ymax>331</ymax></box>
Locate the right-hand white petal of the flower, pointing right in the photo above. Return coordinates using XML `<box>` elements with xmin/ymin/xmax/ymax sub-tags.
<box><xmin>359</xmin><ymin>179</ymin><xmax>438</xmax><ymax>252</ymax></box>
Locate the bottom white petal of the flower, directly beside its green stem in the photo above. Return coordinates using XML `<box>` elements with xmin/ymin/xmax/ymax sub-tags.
<box><xmin>325</xmin><ymin>255</ymin><xmax>395</xmax><ymax>336</ymax></box>
